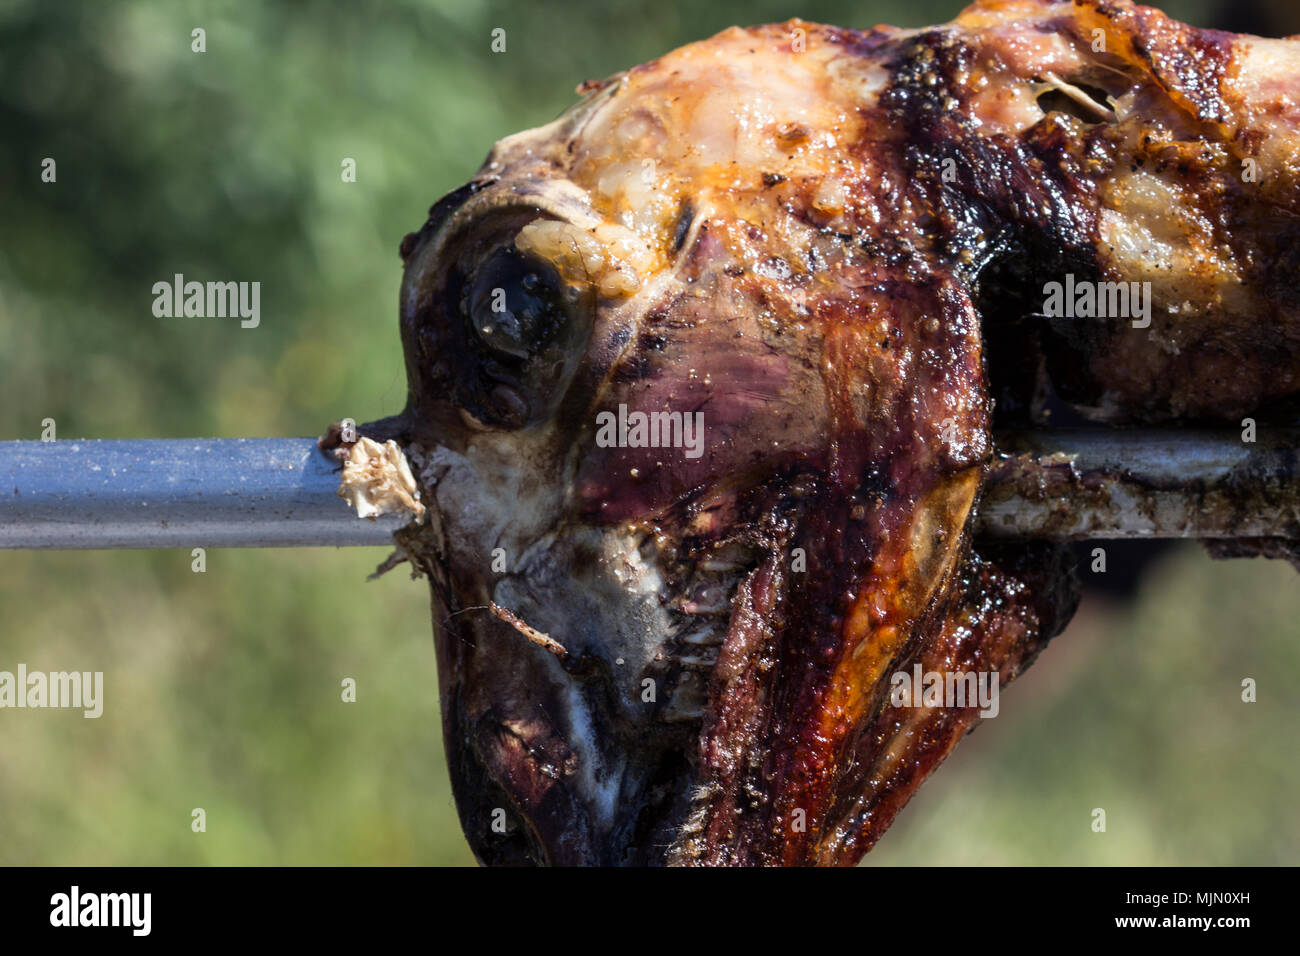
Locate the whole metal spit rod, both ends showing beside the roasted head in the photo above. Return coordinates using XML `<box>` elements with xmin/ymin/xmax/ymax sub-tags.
<box><xmin>0</xmin><ymin>431</ymin><xmax>1300</xmax><ymax>550</ymax></box>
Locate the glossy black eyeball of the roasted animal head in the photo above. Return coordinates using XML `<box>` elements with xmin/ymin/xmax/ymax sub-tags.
<box><xmin>460</xmin><ymin>248</ymin><xmax>569</xmax><ymax>362</ymax></box>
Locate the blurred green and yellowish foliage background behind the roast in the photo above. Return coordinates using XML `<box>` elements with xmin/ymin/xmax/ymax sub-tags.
<box><xmin>0</xmin><ymin>0</ymin><xmax>1300</xmax><ymax>865</ymax></box>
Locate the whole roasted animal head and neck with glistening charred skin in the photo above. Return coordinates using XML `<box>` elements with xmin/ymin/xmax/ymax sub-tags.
<box><xmin>382</xmin><ymin>0</ymin><xmax>1300</xmax><ymax>865</ymax></box>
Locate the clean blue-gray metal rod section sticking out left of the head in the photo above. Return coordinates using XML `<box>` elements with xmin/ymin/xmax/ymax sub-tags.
<box><xmin>0</xmin><ymin>438</ymin><xmax>403</xmax><ymax>549</ymax></box>
